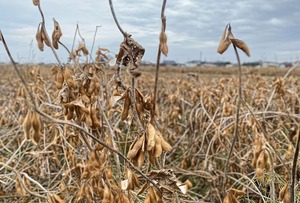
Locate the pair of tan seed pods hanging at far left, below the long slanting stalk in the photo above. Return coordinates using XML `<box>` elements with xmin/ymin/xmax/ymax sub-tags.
<box><xmin>23</xmin><ymin>111</ymin><xmax>41</xmax><ymax>145</ymax></box>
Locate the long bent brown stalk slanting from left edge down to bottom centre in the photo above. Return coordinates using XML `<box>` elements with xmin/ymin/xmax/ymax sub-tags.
<box><xmin>0</xmin><ymin>30</ymin><xmax>161</xmax><ymax>193</ymax></box>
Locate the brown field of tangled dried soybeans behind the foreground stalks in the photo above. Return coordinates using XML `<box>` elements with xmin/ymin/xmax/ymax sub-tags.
<box><xmin>0</xmin><ymin>65</ymin><xmax>300</xmax><ymax>202</ymax></box>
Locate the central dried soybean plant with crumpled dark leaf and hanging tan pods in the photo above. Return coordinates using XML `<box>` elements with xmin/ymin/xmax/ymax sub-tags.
<box><xmin>109</xmin><ymin>0</ymin><xmax>191</xmax><ymax>202</ymax></box>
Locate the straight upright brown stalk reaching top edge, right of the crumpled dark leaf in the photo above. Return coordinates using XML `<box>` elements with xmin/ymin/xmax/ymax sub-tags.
<box><xmin>151</xmin><ymin>0</ymin><xmax>167</xmax><ymax>122</ymax></box>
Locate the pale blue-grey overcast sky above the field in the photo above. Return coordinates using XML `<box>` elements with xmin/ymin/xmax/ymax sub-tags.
<box><xmin>0</xmin><ymin>0</ymin><xmax>300</xmax><ymax>63</ymax></box>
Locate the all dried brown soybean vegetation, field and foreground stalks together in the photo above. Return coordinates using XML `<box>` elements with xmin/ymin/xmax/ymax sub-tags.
<box><xmin>0</xmin><ymin>1</ymin><xmax>300</xmax><ymax>203</ymax></box>
